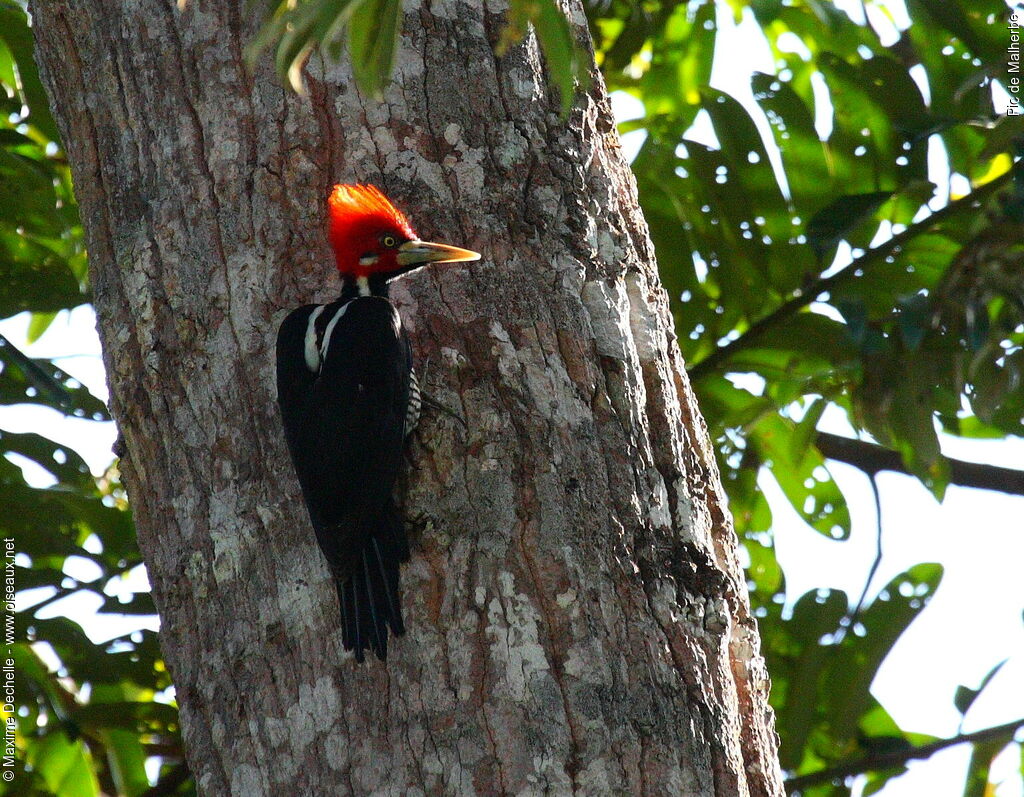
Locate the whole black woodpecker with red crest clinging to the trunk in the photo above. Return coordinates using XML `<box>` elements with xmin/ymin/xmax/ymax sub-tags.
<box><xmin>278</xmin><ymin>185</ymin><xmax>480</xmax><ymax>662</ymax></box>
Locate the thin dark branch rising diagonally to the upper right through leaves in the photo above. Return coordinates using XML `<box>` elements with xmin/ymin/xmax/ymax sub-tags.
<box><xmin>687</xmin><ymin>175</ymin><xmax>1014</xmax><ymax>380</ymax></box>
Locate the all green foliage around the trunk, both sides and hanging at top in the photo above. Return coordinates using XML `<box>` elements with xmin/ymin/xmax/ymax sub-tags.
<box><xmin>8</xmin><ymin>0</ymin><xmax>1024</xmax><ymax>795</ymax></box>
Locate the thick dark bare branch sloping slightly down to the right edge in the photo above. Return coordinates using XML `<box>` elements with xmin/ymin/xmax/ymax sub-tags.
<box><xmin>814</xmin><ymin>431</ymin><xmax>1024</xmax><ymax>496</ymax></box>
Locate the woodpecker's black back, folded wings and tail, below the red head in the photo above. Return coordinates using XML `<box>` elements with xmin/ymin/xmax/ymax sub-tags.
<box><xmin>278</xmin><ymin>296</ymin><xmax>412</xmax><ymax>661</ymax></box>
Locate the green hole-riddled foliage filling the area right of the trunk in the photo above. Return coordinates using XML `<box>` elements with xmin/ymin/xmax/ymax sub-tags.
<box><xmin>590</xmin><ymin>0</ymin><xmax>1024</xmax><ymax>795</ymax></box>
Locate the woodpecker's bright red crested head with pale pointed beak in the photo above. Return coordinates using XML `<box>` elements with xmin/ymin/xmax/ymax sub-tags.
<box><xmin>328</xmin><ymin>185</ymin><xmax>480</xmax><ymax>279</ymax></box>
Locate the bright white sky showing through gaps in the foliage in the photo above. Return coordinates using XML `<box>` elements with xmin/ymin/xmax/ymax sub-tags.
<box><xmin>0</xmin><ymin>0</ymin><xmax>1024</xmax><ymax>797</ymax></box>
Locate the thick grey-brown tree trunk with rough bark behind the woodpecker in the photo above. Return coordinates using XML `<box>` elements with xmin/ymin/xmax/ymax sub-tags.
<box><xmin>32</xmin><ymin>0</ymin><xmax>781</xmax><ymax>786</ymax></box>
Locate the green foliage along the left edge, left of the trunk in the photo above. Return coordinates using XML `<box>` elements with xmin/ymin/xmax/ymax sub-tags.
<box><xmin>0</xmin><ymin>3</ymin><xmax>181</xmax><ymax>797</ymax></box>
